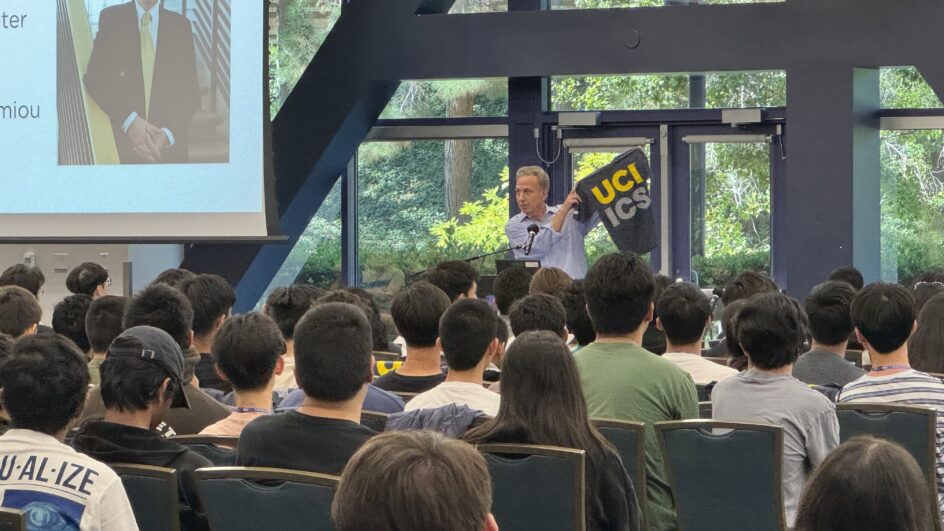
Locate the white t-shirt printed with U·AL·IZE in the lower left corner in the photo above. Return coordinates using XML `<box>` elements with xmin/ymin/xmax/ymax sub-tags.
<box><xmin>0</xmin><ymin>429</ymin><xmax>138</xmax><ymax>531</ymax></box>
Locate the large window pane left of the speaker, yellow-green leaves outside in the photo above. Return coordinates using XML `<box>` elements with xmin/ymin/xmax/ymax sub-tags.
<box><xmin>357</xmin><ymin>138</ymin><xmax>508</xmax><ymax>306</ymax></box>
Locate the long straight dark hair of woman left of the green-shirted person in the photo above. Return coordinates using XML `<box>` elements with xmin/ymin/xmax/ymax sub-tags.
<box><xmin>465</xmin><ymin>330</ymin><xmax>612</xmax><ymax>465</ymax></box>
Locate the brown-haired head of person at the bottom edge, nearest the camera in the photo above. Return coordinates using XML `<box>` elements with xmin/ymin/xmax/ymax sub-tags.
<box><xmin>331</xmin><ymin>431</ymin><xmax>498</xmax><ymax>531</ymax></box>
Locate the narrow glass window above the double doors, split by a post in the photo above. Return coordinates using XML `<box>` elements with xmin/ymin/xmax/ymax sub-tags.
<box><xmin>551</xmin><ymin>70</ymin><xmax>787</xmax><ymax>111</ymax></box>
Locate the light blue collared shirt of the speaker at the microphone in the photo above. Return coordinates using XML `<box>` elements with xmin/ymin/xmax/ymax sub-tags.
<box><xmin>505</xmin><ymin>205</ymin><xmax>600</xmax><ymax>279</ymax></box>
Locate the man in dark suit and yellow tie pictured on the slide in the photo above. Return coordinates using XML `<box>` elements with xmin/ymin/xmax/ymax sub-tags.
<box><xmin>84</xmin><ymin>0</ymin><xmax>200</xmax><ymax>164</ymax></box>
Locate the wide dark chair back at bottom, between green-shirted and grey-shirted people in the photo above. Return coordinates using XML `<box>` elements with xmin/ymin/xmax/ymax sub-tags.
<box><xmin>655</xmin><ymin>420</ymin><xmax>785</xmax><ymax>531</ymax></box>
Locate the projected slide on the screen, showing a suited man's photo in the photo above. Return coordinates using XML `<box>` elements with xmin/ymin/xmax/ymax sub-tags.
<box><xmin>0</xmin><ymin>0</ymin><xmax>267</xmax><ymax>238</ymax></box>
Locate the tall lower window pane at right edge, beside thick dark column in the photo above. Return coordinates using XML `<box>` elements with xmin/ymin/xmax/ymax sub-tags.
<box><xmin>881</xmin><ymin>130</ymin><xmax>944</xmax><ymax>283</ymax></box>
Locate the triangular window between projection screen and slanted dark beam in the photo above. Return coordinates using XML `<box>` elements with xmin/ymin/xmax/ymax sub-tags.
<box><xmin>269</xmin><ymin>0</ymin><xmax>341</xmax><ymax>117</ymax></box>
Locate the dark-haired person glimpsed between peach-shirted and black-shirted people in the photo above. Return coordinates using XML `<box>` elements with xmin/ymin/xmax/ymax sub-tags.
<box><xmin>262</xmin><ymin>284</ymin><xmax>326</xmax><ymax>391</ymax></box>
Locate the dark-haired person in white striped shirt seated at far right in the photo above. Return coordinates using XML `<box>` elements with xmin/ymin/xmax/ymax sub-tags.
<box><xmin>839</xmin><ymin>282</ymin><xmax>944</xmax><ymax>513</ymax></box>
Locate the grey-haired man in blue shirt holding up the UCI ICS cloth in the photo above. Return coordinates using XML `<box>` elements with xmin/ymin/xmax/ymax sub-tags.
<box><xmin>505</xmin><ymin>166</ymin><xmax>600</xmax><ymax>279</ymax></box>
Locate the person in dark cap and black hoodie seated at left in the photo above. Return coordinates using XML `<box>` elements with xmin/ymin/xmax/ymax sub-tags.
<box><xmin>72</xmin><ymin>326</ymin><xmax>213</xmax><ymax>529</ymax></box>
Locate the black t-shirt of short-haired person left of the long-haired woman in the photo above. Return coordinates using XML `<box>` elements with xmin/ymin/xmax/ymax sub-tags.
<box><xmin>236</xmin><ymin>411</ymin><xmax>376</xmax><ymax>475</ymax></box>
